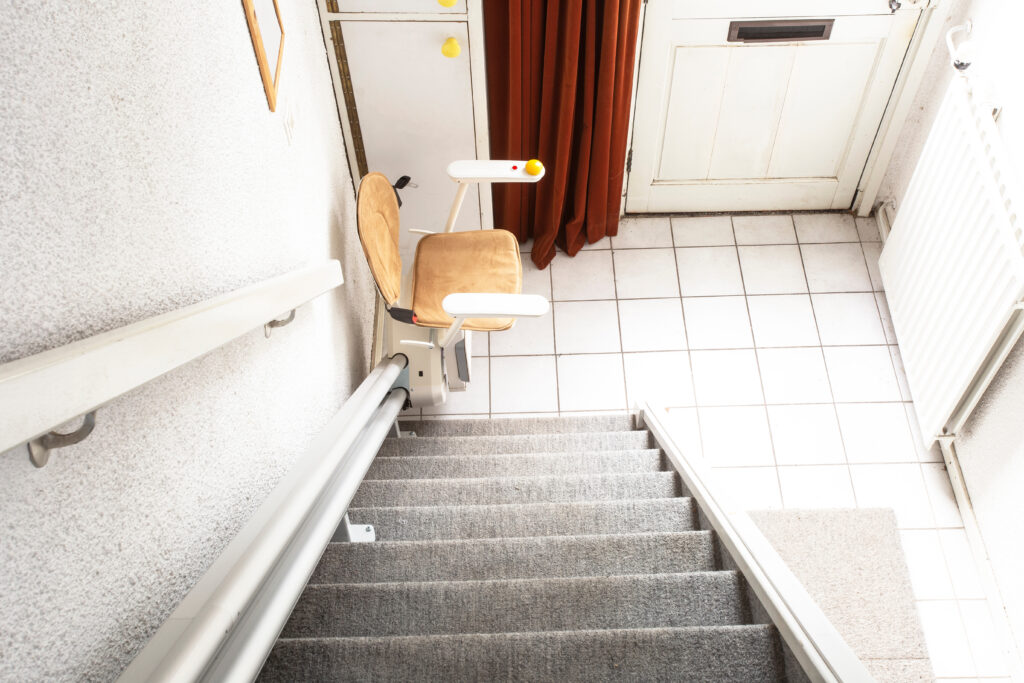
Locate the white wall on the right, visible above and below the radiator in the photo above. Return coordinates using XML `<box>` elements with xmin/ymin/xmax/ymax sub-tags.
<box><xmin>880</xmin><ymin>0</ymin><xmax>1024</xmax><ymax>651</ymax></box>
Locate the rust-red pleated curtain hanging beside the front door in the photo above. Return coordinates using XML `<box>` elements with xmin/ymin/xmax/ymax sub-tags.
<box><xmin>483</xmin><ymin>0</ymin><xmax>642</xmax><ymax>268</ymax></box>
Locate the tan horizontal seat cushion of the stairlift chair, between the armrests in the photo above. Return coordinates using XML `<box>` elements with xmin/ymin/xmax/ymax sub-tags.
<box><xmin>413</xmin><ymin>229</ymin><xmax>522</xmax><ymax>332</ymax></box>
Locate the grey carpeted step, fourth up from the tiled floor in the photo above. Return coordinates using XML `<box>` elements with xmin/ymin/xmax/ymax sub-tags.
<box><xmin>352</xmin><ymin>472</ymin><xmax>681</xmax><ymax>507</ymax></box>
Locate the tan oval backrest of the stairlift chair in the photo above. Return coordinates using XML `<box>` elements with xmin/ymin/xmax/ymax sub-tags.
<box><xmin>355</xmin><ymin>173</ymin><xmax>401</xmax><ymax>306</ymax></box>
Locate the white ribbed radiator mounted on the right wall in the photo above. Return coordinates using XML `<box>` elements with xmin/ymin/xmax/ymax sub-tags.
<box><xmin>879</xmin><ymin>77</ymin><xmax>1024</xmax><ymax>445</ymax></box>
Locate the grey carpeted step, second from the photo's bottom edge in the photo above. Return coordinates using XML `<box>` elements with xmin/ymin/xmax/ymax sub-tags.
<box><xmin>282</xmin><ymin>571</ymin><xmax>750</xmax><ymax>638</ymax></box>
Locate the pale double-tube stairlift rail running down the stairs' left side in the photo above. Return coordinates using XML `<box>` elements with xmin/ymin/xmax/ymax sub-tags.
<box><xmin>118</xmin><ymin>354</ymin><xmax>409</xmax><ymax>683</ymax></box>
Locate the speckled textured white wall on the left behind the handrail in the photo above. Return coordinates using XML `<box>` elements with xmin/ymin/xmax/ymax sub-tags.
<box><xmin>0</xmin><ymin>0</ymin><xmax>373</xmax><ymax>681</ymax></box>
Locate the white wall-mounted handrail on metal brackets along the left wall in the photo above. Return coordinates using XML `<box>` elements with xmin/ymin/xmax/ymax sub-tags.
<box><xmin>0</xmin><ymin>260</ymin><xmax>343</xmax><ymax>452</ymax></box>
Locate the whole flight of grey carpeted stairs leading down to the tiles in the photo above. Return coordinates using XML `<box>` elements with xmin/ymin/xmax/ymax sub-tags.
<box><xmin>260</xmin><ymin>416</ymin><xmax>784</xmax><ymax>683</ymax></box>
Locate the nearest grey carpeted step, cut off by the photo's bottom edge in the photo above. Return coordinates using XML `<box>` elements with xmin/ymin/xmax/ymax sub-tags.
<box><xmin>259</xmin><ymin>625</ymin><xmax>784</xmax><ymax>683</ymax></box>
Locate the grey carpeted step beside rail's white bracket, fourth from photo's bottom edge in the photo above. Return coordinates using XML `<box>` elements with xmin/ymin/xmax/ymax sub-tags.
<box><xmin>348</xmin><ymin>498</ymin><xmax>696</xmax><ymax>541</ymax></box>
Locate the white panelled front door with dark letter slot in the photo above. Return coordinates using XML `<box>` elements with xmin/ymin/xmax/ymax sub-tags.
<box><xmin>626</xmin><ymin>0</ymin><xmax>919</xmax><ymax>213</ymax></box>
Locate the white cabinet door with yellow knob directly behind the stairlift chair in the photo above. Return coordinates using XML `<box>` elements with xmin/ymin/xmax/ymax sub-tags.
<box><xmin>341</xmin><ymin>20</ymin><xmax>477</xmax><ymax>258</ymax></box>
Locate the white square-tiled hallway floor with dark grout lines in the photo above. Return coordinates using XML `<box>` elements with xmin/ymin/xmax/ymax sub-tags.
<box><xmin>403</xmin><ymin>214</ymin><xmax>1009</xmax><ymax>680</ymax></box>
